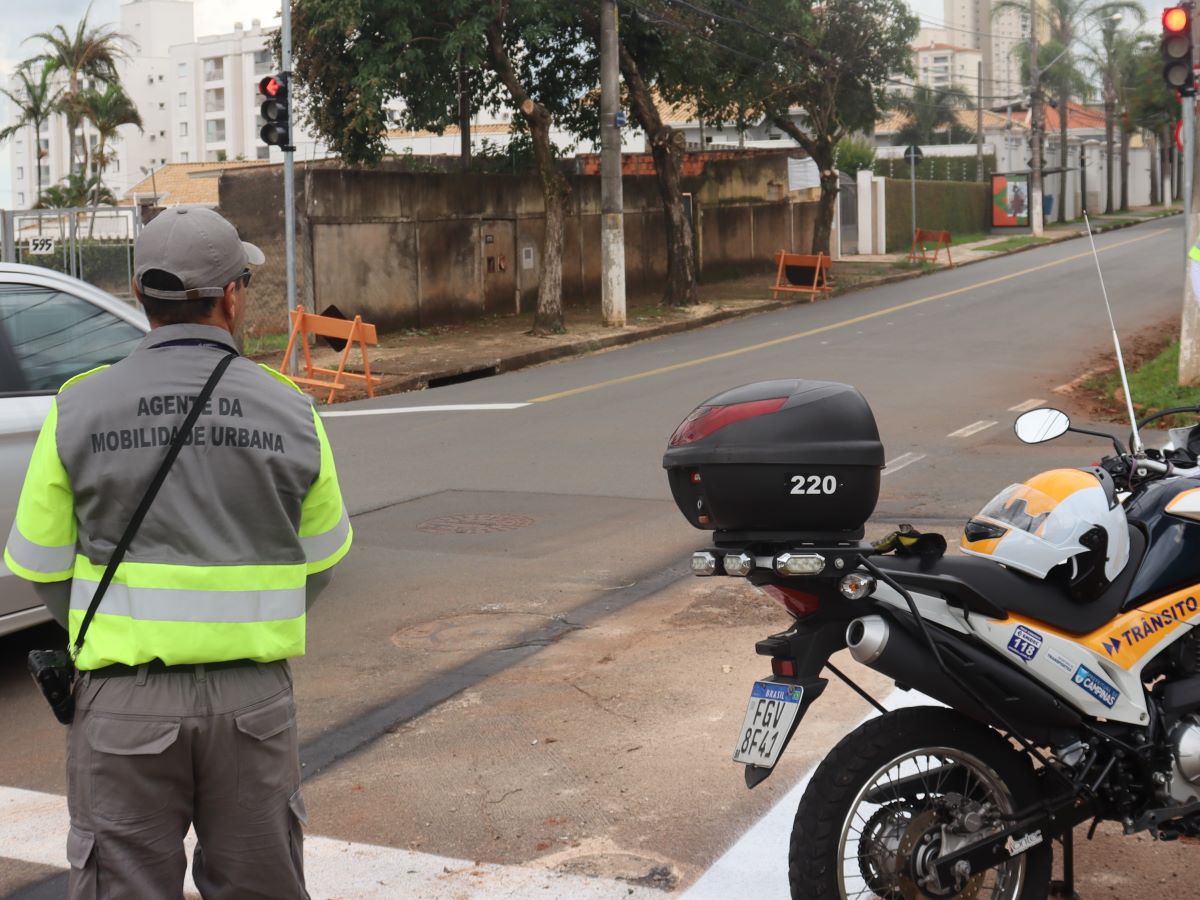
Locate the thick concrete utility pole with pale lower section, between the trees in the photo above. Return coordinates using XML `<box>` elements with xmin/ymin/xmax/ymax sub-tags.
<box><xmin>600</xmin><ymin>0</ymin><xmax>625</xmax><ymax>328</ymax></box>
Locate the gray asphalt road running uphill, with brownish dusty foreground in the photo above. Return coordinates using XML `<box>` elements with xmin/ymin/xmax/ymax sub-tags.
<box><xmin>0</xmin><ymin>220</ymin><xmax>1182</xmax><ymax>898</ymax></box>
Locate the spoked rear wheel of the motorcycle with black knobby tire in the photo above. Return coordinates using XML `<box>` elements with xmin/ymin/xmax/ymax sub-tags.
<box><xmin>788</xmin><ymin>707</ymin><xmax>1054</xmax><ymax>900</ymax></box>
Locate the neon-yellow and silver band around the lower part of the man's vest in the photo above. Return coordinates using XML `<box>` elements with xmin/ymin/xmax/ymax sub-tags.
<box><xmin>70</xmin><ymin>557</ymin><xmax>306</xmax><ymax>670</ymax></box>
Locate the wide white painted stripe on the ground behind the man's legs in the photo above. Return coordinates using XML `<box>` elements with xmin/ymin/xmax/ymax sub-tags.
<box><xmin>0</xmin><ymin>787</ymin><xmax>662</xmax><ymax>900</ymax></box>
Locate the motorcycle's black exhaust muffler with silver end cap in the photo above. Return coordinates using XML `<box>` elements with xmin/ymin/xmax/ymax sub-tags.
<box><xmin>846</xmin><ymin>613</ymin><xmax>1080</xmax><ymax>734</ymax></box>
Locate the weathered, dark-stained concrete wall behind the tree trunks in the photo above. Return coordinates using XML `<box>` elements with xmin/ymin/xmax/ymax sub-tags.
<box><xmin>220</xmin><ymin>155</ymin><xmax>816</xmax><ymax>331</ymax></box>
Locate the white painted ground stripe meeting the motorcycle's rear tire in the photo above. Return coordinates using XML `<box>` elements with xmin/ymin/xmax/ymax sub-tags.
<box><xmin>680</xmin><ymin>690</ymin><xmax>941</xmax><ymax>900</ymax></box>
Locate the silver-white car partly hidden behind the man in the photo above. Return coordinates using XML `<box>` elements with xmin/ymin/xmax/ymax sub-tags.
<box><xmin>0</xmin><ymin>263</ymin><xmax>150</xmax><ymax>635</ymax></box>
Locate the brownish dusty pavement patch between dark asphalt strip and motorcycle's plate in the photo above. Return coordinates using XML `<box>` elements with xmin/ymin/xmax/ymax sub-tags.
<box><xmin>305</xmin><ymin>578</ymin><xmax>890</xmax><ymax>887</ymax></box>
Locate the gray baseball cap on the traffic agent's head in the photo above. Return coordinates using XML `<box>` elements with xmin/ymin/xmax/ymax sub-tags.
<box><xmin>133</xmin><ymin>206</ymin><xmax>265</xmax><ymax>300</ymax></box>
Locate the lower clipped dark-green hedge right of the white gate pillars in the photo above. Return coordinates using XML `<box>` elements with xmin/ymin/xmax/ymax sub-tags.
<box><xmin>883</xmin><ymin>178</ymin><xmax>991</xmax><ymax>253</ymax></box>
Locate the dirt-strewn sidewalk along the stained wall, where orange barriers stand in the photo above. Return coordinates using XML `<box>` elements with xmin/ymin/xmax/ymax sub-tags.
<box><xmin>260</xmin><ymin>208</ymin><xmax>1171</xmax><ymax>401</ymax></box>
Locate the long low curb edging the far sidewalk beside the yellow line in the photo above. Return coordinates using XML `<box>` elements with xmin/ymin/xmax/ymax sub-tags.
<box><xmin>347</xmin><ymin>212</ymin><xmax>1182</xmax><ymax>401</ymax></box>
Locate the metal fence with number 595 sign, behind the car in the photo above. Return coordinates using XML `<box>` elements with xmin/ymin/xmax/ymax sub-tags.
<box><xmin>0</xmin><ymin>206</ymin><xmax>142</xmax><ymax>296</ymax></box>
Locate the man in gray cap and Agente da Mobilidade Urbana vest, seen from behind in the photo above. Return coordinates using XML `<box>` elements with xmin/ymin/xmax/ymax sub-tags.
<box><xmin>5</xmin><ymin>208</ymin><xmax>352</xmax><ymax>900</ymax></box>
